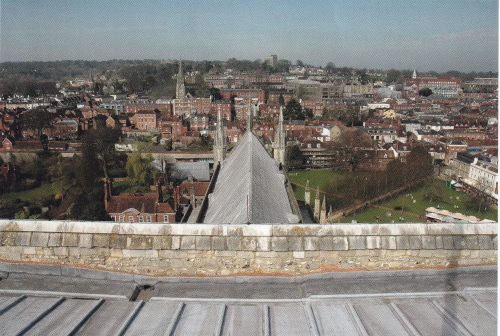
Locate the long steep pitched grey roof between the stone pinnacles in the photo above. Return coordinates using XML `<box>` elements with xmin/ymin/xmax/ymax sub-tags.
<box><xmin>204</xmin><ymin>132</ymin><xmax>298</xmax><ymax>224</ymax></box>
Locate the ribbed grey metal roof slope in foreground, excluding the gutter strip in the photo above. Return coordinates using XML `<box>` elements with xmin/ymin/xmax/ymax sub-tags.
<box><xmin>0</xmin><ymin>289</ymin><xmax>497</xmax><ymax>336</ymax></box>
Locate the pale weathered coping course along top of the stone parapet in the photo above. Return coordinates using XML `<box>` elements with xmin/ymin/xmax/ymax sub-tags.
<box><xmin>0</xmin><ymin>220</ymin><xmax>498</xmax><ymax>237</ymax></box>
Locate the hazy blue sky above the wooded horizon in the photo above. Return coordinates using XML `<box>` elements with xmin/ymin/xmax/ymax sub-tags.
<box><xmin>0</xmin><ymin>0</ymin><xmax>499</xmax><ymax>72</ymax></box>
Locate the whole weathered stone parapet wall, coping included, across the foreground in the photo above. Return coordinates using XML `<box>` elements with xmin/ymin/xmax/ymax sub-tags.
<box><xmin>0</xmin><ymin>220</ymin><xmax>498</xmax><ymax>276</ymax></box>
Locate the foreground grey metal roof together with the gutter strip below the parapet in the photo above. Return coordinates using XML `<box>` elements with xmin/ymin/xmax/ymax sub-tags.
<box><xmin>0</xmin><ymin>263</ymin><xmax>498</xmax><ymax>336</ymax></box>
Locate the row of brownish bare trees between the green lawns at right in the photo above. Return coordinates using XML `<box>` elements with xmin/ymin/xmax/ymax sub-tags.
<box><xmin>324</xmin><ymin>147</ymin><xmax>433</xmax><ymax>210</ymax></box>
